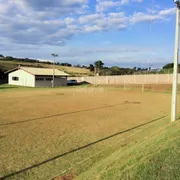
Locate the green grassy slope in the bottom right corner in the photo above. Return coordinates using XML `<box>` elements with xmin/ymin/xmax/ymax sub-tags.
<box><xmin>77</xmin><ymin>118</ymin><xmax>180</xmax><ymax>180</ymax></box>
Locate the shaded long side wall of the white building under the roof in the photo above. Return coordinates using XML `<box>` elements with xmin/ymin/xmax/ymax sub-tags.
<box><xmin>35</xmin><ymin>76</ymin><xmax>67</xmax><ymax>87</ymax></box>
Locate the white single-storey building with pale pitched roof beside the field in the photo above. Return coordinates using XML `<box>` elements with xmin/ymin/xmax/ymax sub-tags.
<box><xmin>6</xmin><ymin>67</ymin><xmax>68</xmax><ymax>87</ymax></box>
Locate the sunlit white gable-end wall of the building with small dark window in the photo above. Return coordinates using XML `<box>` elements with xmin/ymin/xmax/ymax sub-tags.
<box><xmin>8</xmin><ymin>69</ymin><xmax>35</xmax><ymax>87</ymax></box>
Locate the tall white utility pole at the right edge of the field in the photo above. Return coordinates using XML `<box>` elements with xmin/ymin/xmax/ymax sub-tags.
<box><xmin>171</xmin><ymin>0</ymin><xmax>180</xmax><ymax>122</ymax></box>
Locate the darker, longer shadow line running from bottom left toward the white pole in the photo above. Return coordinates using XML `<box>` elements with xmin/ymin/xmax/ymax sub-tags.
<box><xmin>1</xmin><ymin>116</ymin><xmax>167</xmax><ymax>180</ymax></box>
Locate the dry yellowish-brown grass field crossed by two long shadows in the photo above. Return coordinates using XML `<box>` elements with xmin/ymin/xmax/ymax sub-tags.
<box><xmin>0</xmin><ymin>87</ymin><xmax>179</xmax><ymax>180</ymax></box>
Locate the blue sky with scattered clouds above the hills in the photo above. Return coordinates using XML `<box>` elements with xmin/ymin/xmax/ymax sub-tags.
<box><xmin>0</xmin><ymin>0</ymin><xmax>178</xmax><ymax>68</ymax></box>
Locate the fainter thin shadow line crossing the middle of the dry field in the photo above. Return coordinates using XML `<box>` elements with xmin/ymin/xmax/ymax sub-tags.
<box><xmin>0</xmin><ymin>102</ymin><xmax>126</xmax><ymax>126</ymax></box>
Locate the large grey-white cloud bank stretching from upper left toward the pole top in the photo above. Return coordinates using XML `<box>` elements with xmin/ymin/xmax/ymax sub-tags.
<box><xmin>0</xmin><ymin>0</ymin><xmax>175</xmax><ymax>49</ymax></box>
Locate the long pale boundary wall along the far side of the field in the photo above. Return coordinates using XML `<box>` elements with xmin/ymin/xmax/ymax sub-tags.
<box><xmin>68</xmin><ymin>74</ymin><xmax>180</xmax><ymax>85</ymax></box>
